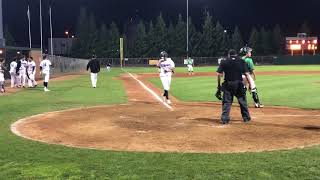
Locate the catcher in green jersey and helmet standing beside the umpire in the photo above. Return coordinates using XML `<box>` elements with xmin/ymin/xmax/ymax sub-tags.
<box><xmin>240</xmin><ymin>47</ymin><xmax>264</xmax><ymax>108</ymax></box>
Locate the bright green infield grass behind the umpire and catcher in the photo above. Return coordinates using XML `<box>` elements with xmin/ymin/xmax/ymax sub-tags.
<box><xmin>150</xmin><ymin>75</ymin><xmax>320</xmax><ymax>109</ymax></box>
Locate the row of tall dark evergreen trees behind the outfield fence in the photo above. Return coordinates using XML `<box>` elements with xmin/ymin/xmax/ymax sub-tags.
<box><xmin>71</xmin><ymin>9</ymin><xmax>308</xmax><ymax>58</ymax></box>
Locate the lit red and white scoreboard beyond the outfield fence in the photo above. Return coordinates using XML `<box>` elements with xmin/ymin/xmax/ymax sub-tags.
<box><xmin>286</xmin><ymin>33</ymin><xmax>318</xmax><ymax>55</ymax></box>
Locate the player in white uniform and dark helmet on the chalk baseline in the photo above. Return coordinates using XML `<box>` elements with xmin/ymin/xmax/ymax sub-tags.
<box><xmin>158</xmin><ymin>51</ymin><xmax>175</xmax><ymax>104</ymax></box>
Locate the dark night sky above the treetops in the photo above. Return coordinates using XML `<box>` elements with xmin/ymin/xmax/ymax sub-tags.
<box><xmin>3</xmin><ymin>0</ymin><xmax>320</xmax><ymax>46</ymax></box>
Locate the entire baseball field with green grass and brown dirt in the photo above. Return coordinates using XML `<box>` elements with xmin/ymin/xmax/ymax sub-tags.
<box><xmin>0</xmin><ymin>65</ymin><xmax>320</xmax><ymax>179</ymax></box>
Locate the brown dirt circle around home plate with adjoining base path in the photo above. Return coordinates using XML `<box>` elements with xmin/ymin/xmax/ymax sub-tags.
<box><xmin>12</xmin><ymin>72</ymin><xmax>320</xmax><ymax>153</ymax></box>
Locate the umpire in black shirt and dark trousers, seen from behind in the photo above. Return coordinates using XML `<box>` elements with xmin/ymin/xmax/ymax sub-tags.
<box><xmin>217</xmin><ymin>50</ymin><xmax>251</xmax><ymax>124</ymax></box>
